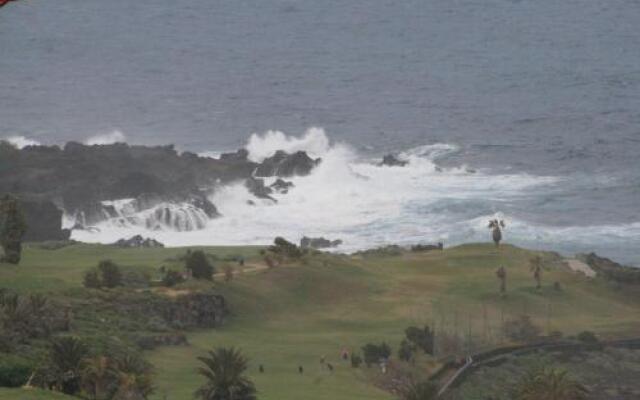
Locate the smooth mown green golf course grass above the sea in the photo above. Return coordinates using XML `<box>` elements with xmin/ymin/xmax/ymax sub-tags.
<box><xmin>0</xmin><ymin>245</ymin><xmax>640</xmax><ymax>400</ymax></box>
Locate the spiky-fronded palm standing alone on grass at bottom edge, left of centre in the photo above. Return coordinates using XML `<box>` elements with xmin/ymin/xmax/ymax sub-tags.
<box><xmin>195</xmin><ymin>347</ymin><xmax>256</xmax><ymax>400</ymax></box>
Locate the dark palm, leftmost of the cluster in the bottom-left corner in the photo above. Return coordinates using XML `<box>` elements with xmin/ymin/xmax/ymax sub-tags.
<box><xmin>49</xmin><ymin>336</ymin><xmax>89</xmax><ymax>394</ymax></box>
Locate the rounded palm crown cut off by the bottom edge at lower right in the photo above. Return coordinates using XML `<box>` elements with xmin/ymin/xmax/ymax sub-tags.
<box><xmin>515</xmin><ymin>368</ymin><xmax>589</xmax><ymax>400</ymax></box>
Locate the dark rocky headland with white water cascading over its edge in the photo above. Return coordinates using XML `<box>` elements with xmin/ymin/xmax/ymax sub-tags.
<box><xmin>0</xmin><ymin>141</ymin><xmax>320</xmax><ymax>240</ymax></box>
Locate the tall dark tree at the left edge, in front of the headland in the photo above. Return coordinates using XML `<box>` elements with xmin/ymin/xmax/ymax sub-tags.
<box><xmin>0</xmin><ymin>195</ymin><xmax>27</xmax><ymax>264</ymax></box>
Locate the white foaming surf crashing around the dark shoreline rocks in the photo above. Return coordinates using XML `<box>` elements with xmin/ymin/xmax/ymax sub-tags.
<box><xmin>73</xmin><ymin>128</ymin><xmax>640</xmax><ymax>266</ymax></box>
